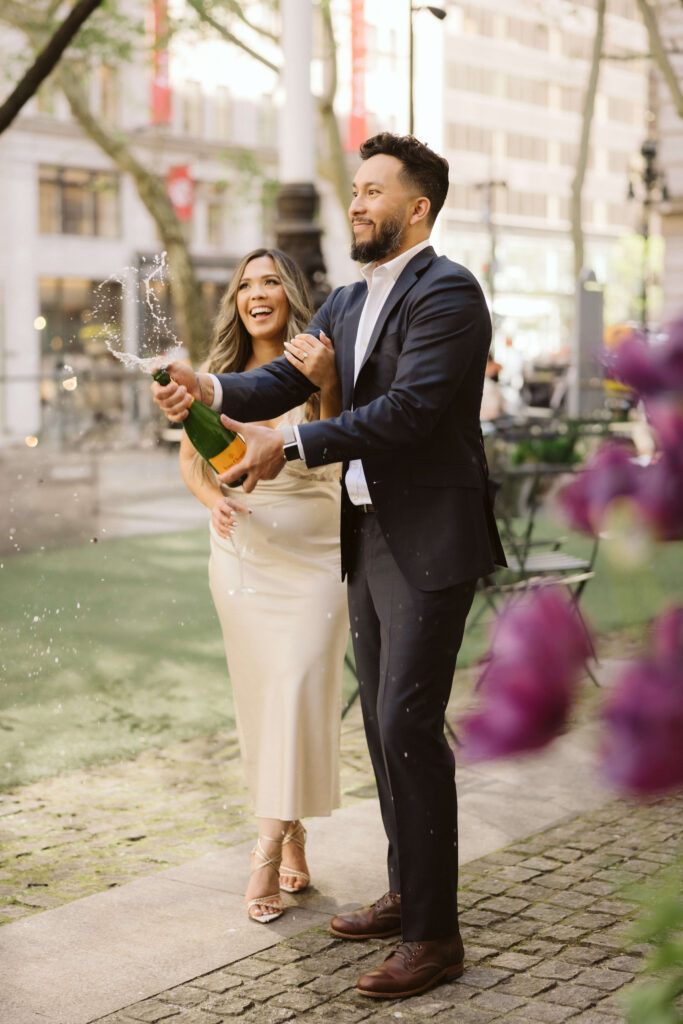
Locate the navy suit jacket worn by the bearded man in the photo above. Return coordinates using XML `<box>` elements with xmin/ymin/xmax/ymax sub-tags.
<box><xmin>219</xmin><ymin>247</ymin><xmax>505</xmax><ymax>590</ymax></box>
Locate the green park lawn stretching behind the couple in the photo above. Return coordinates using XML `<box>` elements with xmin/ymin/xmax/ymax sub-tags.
<box><xmin>0</xmin><ymin>520</ymin><xmax>683</xmax><ymax>788</ymax></box>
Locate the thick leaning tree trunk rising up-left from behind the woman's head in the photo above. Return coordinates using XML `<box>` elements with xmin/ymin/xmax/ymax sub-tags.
<box><xmin>57</xmin><ymin>67</ymin><xmax>209</xmax><ymax>362</ymax></box>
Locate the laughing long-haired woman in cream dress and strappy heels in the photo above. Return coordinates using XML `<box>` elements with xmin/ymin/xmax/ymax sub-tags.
<box><xmin>180</xmin><ymin>249</ymin><xmax>348</xmax><ymax>923</ymax></box>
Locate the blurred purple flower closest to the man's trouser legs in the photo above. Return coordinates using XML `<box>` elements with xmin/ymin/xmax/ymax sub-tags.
<box><xmin>461</xmin><ymin>588</ymin><xmax>591</xmax><ymax>761</ymax></box>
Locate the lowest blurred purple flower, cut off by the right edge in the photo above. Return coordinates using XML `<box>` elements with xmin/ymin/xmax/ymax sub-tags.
<box><xmin>601</xmin><ymin>608</ymin><xmax>683</xmax><ymax>796</ymax></box>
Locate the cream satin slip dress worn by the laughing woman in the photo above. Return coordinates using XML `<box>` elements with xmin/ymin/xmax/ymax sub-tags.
<box><xmin>209</xmin><ymin>407</ymin><xmax>348</xmax><ymax>821</ymax></box>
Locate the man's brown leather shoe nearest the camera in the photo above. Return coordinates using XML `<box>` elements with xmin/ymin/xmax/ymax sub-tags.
<box><xmin>357</xmin><ymin>935</ymin><xmax>464</xmax><ymax>999</ymax></box>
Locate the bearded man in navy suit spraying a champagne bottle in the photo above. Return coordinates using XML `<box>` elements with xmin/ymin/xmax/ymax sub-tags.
<box><xmin>153</xmin><ymin>132</ymin><xmax>505</xmax><ymax>998</ymax></box>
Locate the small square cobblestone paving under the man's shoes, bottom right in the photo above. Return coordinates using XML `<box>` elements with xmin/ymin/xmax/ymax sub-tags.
<box><xmin>87</xmin><ymin>797</ymin><xmax>683</xmax><ymax>1024</ymax></box>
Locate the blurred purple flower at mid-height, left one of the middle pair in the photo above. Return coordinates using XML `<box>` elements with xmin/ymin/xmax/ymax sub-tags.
<box><xmin>558</xmin><ymin>442</ymin><xmax>643</xmax><ymax>536</ymax></box>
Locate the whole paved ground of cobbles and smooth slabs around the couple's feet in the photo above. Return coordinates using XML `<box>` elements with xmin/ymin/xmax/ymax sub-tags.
<box><xmin>0</xmin><ymin>630</ymin><xmax>683</xmax><ymax>1024</ymax></box>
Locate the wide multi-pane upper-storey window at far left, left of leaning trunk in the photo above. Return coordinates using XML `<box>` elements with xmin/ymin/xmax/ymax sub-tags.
<box><xmin>38</xmin><ymin>165</ymin><xmax>121</xmax><ymax>239</ymax></box>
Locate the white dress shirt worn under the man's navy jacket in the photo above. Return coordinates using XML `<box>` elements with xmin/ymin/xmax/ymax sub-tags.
<box><xmin>210</xmin><ymin>239</ymin><xmax>430</xmax><ymax>505</ymax></box>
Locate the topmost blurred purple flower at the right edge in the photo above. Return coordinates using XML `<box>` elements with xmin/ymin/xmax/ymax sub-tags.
<box><xmin>604</xmin><ymin>317</ymin><xmax>683</xmax><ymax>396</ymax></box>
